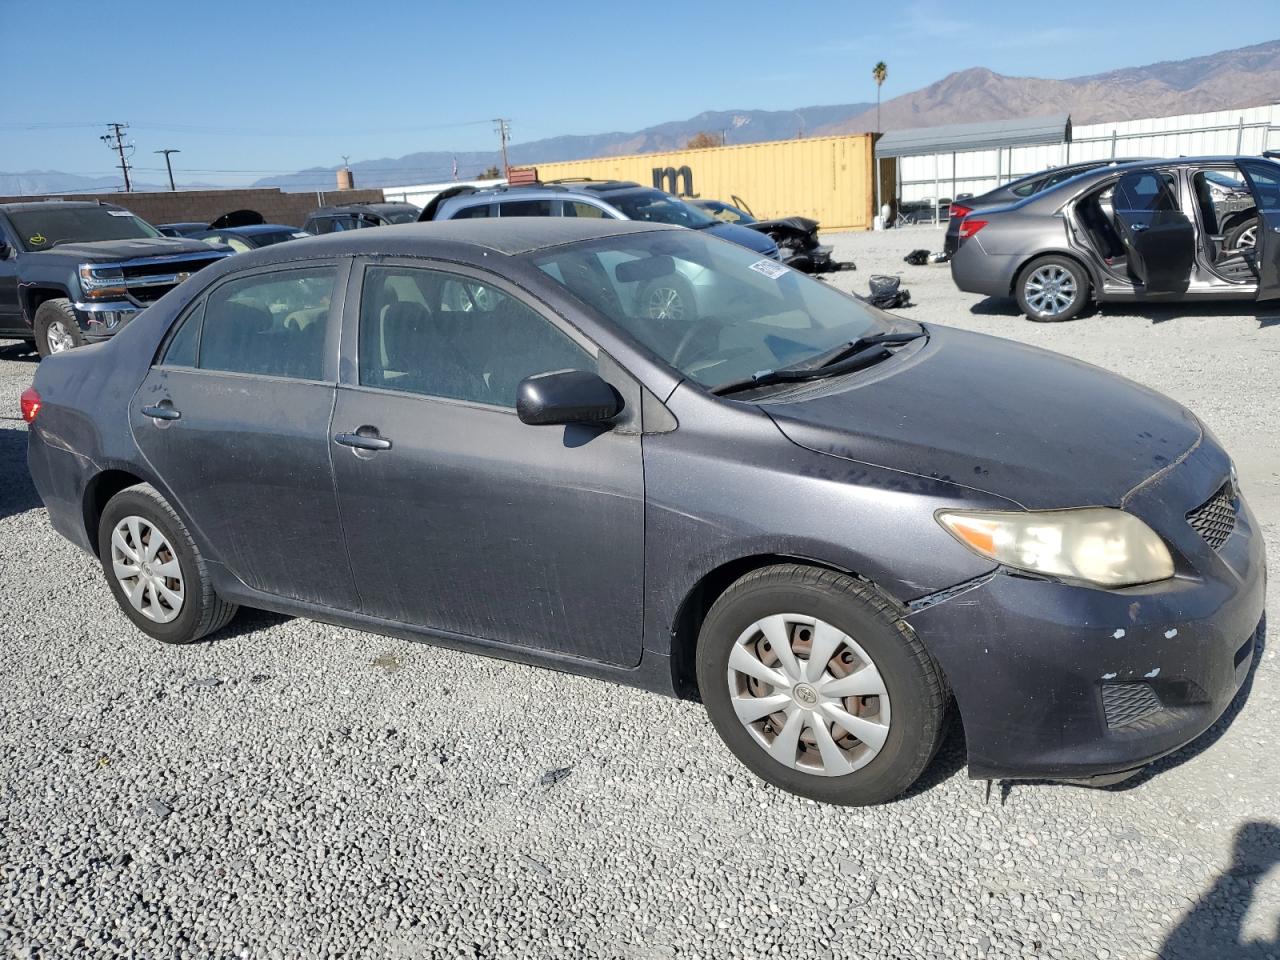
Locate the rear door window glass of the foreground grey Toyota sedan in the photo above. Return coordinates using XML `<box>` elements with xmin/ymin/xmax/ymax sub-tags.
<box><xmin>164</xmin><ymin>266</ymin><xmax>338</xmax><ymax>380</ymax></box>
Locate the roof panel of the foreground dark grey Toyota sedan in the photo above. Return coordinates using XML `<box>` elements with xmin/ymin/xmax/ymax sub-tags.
<box><xmin>211</xmin><ymin>216</ymin><xmax>685</xmax><ymax>266</ymax></box>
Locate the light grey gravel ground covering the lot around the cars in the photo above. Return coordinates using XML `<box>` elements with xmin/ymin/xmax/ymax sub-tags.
<box><xmin>0</xmin><ymin>228</ymin><xmax>1280</xmax><ymax>960</ymax></box>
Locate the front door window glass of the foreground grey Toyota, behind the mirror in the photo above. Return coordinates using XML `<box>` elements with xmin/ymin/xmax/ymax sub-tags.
<box><xmin>360</xmin><ymin>266</ymin><xmax>595</xmax><ymax>408</ymax></box>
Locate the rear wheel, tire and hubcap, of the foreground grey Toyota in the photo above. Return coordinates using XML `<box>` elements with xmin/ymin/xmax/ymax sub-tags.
<box><xmin>97</xmin><ymin>484</ymin><xmax>237</xmax><ymax>644</ymax></box>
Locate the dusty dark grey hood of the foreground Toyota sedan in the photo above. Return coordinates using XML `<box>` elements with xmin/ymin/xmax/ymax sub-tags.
<box><xmin>762</xmin><ymin>325</ymin><xmax>1202</xmax><ymax>509</ymax></box>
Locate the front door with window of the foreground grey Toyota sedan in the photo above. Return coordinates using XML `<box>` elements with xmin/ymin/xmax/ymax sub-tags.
<box><xmin>333</xmin><ymin>264</ymin><xmax>644</xmax><ymax>666</ymax></box>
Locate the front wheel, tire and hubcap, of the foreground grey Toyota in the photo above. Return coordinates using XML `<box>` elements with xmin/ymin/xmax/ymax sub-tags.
<box><xmin>696</xmin><ymin>564</ymin><xmax>946</xmax><ymax>806</ymax></box>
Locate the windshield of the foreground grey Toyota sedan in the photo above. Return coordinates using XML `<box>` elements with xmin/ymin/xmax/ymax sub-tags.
<box><xmin>532</xmin><ymin>230</ymin><xmax>888</xmax><ymax>388</ymax></box>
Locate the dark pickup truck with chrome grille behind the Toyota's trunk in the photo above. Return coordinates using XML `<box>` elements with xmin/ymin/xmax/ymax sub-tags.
<box><xmin>0</xmin><ymin>200</ymin><xmax>232</xmax><ymax>357</ymax></box>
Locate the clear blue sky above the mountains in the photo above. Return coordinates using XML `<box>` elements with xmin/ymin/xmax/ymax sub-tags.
<box><xmin>0</xmin><ymin>0</ymin><xmax>1271</xmax><ymax>183</ymax></box>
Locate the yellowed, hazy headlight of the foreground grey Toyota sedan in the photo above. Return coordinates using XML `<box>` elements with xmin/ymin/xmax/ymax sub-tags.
<box><xmin>937</xmin><ymin>507</ymin><xmax>1174</xmax><ymax>586</ymax></box>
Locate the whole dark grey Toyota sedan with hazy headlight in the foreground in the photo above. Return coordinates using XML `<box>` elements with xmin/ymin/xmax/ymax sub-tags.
<box><xmin>23</xmin><ymin>218</ymin><xmax>1265</xmax><ymax>804</ymax></box>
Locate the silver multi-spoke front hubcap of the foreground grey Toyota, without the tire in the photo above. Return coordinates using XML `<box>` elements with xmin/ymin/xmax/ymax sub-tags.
<box><xmin>728</xmin><ymin>613</ymin><xmax>890</xmax><ymax>777</ymax></box>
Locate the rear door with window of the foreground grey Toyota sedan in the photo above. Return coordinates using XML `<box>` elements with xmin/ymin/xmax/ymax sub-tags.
<box><xmin>131</xmin><ymin>262</ymin><xmax>358</xmax><ymax>611</ymax></box>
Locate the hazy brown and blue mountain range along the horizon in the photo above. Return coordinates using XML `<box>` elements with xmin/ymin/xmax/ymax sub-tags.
<box><xmin>0</xmin><ymin>40</ymin><xmax>1280</xmax><ymax>195</ymax></box>
